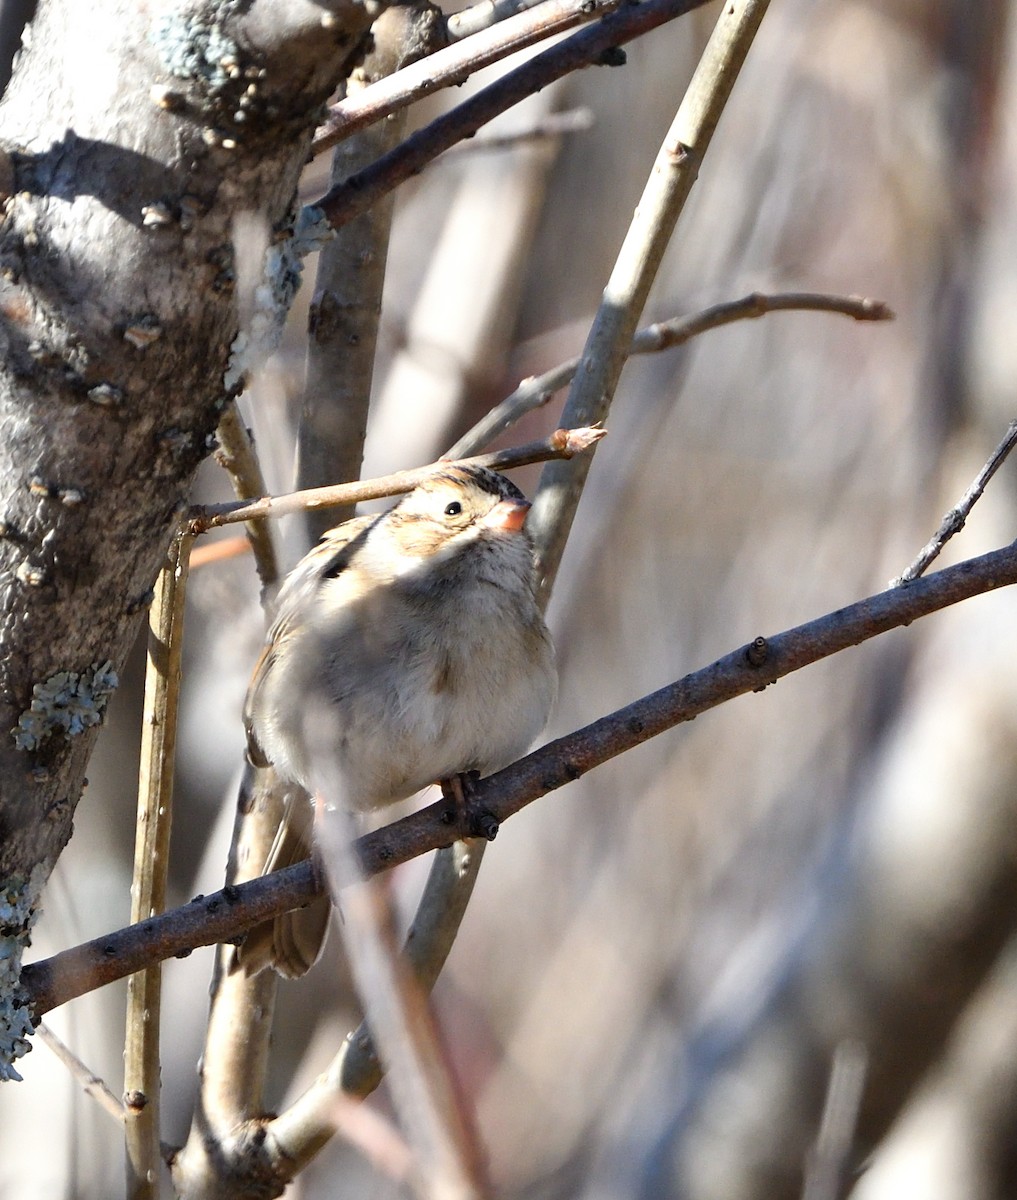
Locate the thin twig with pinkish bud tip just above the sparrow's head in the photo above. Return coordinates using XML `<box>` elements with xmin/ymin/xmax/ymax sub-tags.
<box><xmin>187</xmin><ymin>428</ymin><xmax>607</xmax><ymax>534</ymax></box>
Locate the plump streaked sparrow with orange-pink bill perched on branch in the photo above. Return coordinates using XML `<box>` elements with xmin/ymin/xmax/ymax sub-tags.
<box><xmin>237</xmin><ymin>466</ymin><xmax>556</xmax><ymax>977</ymax></box>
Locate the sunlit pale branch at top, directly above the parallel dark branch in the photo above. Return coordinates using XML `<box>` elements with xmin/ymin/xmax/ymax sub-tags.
<box><xmin>311</xmin><ymin>0</ymin><xmax>620</xmax><ymax>155</ymax></box>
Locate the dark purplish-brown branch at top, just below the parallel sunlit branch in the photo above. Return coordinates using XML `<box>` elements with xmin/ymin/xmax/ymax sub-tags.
<box><xmin>318</xmin><ymin>0</ymin><xmax>706</xmax><ymax>228</ymax></box>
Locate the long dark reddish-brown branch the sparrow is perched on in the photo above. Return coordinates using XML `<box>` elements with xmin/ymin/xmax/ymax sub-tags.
<box><xmin>22</xmin><ymin>544</ymin><xmax>1017</xmax><ymax>1016</ymax></box>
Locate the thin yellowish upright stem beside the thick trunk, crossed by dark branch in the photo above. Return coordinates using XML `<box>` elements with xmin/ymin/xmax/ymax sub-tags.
<box><xmin>124</xmin><ymin>533</ymin><xmax>191</xmax><ymax>1200</ymax></box>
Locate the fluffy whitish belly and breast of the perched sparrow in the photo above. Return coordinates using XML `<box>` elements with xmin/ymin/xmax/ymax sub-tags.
<box><xmin>259</xmin><ymin>568</ymin><xmax>555</xmax><ymax>809</ymax></box>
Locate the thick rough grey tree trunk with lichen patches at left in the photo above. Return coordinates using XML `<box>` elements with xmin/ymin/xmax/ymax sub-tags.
<box><xmin>0</xmin><ymin>0</ymin><xmax>369</xmax><ymax>945</ymax></box>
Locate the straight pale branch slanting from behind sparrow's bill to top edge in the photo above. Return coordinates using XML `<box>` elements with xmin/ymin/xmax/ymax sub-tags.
<box><xmin>530</xmin><ymin>0</ymin><xmax>769</xmax><ymax>604</ymax></box>
